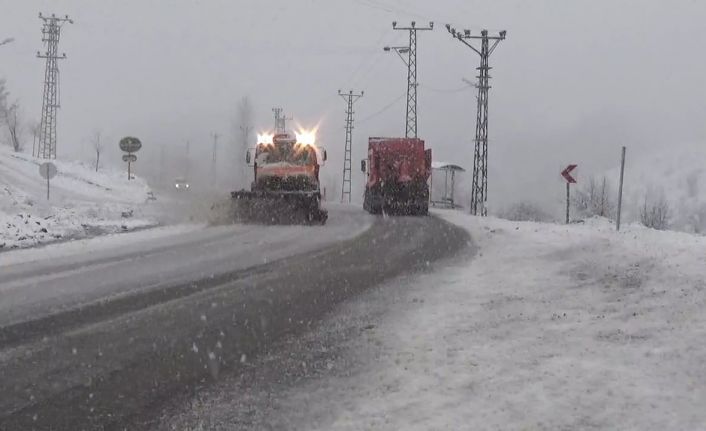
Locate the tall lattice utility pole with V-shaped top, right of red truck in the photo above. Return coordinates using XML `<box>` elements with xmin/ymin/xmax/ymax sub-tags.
<box><xmin>446</xmin><ymin>24</ymin><xmax>507</xmax><ymax>216</ymax></box>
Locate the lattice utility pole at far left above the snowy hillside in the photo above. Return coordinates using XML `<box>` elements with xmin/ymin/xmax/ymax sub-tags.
<box><xmin>37</xmin><ymin>13</ymin><xmax>73</xmax><ymax>159</ymax></box>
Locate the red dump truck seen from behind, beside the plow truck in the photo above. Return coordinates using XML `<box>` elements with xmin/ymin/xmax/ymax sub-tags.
<box><xmin>361</xmin><ymin>138</ymin><xmax>431</xmax><ymax>215</ymax></box>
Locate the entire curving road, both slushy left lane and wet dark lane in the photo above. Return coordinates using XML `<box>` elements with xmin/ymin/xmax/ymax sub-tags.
<box><xmin>0</xmin><ymin>211</ymin><xmax>468</xmax><ymax>430</ymax></box>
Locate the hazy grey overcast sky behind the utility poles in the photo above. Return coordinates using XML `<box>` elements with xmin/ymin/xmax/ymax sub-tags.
<box><xmin>0</xmin><ymin>0</ymin><xmax>706</xmax><ymax>207</ymax></box>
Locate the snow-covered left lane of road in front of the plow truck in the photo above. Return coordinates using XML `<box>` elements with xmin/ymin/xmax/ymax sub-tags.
<box><xmin>0</xmin><ymin>205</ymin><xmax>372</xmax><ymax>326</ymax></box>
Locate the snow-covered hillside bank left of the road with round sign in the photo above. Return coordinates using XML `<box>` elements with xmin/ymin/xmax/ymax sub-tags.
<box><xmin>0</xmin><ymin>147</ymin><xmax>155</xmax><ymax>251</ymax></box>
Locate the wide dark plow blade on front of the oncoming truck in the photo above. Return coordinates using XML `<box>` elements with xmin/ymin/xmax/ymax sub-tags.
<box><xmin>231</xmin><ymin>190</ymin><xmax>328</xmax><ymax>225</ymax></box>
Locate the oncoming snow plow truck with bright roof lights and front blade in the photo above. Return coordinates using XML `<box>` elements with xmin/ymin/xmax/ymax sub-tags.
<box><xmin>231</xmin><ymin>131</ymin><xmax>328</xmax><ymax>224</ymax></box>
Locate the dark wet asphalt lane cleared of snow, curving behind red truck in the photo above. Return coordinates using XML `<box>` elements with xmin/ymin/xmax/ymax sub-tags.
<box><xmin>0</xmin><ymin>217</ymin><xmax>469</xmax><ymax>430</ymax></box>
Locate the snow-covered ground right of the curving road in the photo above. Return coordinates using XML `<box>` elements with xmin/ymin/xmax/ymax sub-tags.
<box><xmin>168</xmin><ymin>211</ymin><xmax>706</xmax><ymax>431</ymax></box>
